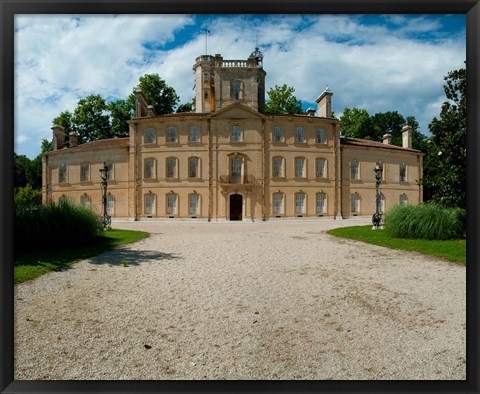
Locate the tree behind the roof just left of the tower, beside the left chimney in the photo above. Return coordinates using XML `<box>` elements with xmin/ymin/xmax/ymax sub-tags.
<box><xmin>128</xmin><ymin>74</ymin><xmax>180</xmax><ymax>115</ymax></box>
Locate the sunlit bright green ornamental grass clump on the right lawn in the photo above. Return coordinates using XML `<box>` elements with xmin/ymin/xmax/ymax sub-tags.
<box><xmin>385</xmin><ymin>204</ymin><xmax>467</xmax><ymax>240</ymax></box>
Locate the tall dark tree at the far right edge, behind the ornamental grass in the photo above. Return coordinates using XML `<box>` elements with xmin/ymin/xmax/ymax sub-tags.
<box><xmin>422</xmin><ymin>68</ymin><xmax>467</xmax><ymax>208</ymax></box>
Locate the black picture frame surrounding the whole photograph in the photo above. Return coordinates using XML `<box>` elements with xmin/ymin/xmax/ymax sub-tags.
<box><xmin>0</xmin><ymin>0</ymin><xmax>480</xmax><ymax>393</ymax></box>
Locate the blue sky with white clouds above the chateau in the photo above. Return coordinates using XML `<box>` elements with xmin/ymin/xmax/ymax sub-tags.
<box><xmin>14</xmin><ymin>14</ymin><xmax>466</xmax><ymax>159</ymax></box>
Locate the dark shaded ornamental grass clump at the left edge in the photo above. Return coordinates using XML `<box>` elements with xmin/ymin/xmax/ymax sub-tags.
<box><xmin>15</xmin><ymin>200</ymin><xmax>101</xmax><ymax>250</ymax></box>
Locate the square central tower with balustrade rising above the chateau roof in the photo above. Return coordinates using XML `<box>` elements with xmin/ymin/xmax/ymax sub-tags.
<box><xmin>193</xmin><ymin>48</ymin><xmax>266</xmax><ymax>112</ymax></box>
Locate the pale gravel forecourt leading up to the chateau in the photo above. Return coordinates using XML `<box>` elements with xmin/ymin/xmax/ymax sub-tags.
<box><xmin>15</xmin><ymin>219</ymin><xmax>466</xmax><ymax>380</ymax></box>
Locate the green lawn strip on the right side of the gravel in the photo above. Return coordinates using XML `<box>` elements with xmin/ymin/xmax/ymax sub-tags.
<box><xmin>327</xmin><ymin>225</ymin><xmax>467</xmax><ymax>264</ymax></box>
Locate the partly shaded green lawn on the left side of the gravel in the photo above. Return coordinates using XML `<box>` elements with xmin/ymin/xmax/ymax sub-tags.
<box><xmin>13</xmin><ymin>229</ymin><xmax>150</xmax><ymax>283</ymax></box>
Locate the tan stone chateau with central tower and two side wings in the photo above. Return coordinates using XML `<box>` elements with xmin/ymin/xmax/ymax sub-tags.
<box><xmin>42</xmin><ymin>48</ymin><xmax>423</xmax><ymax>221</ymax></box>
